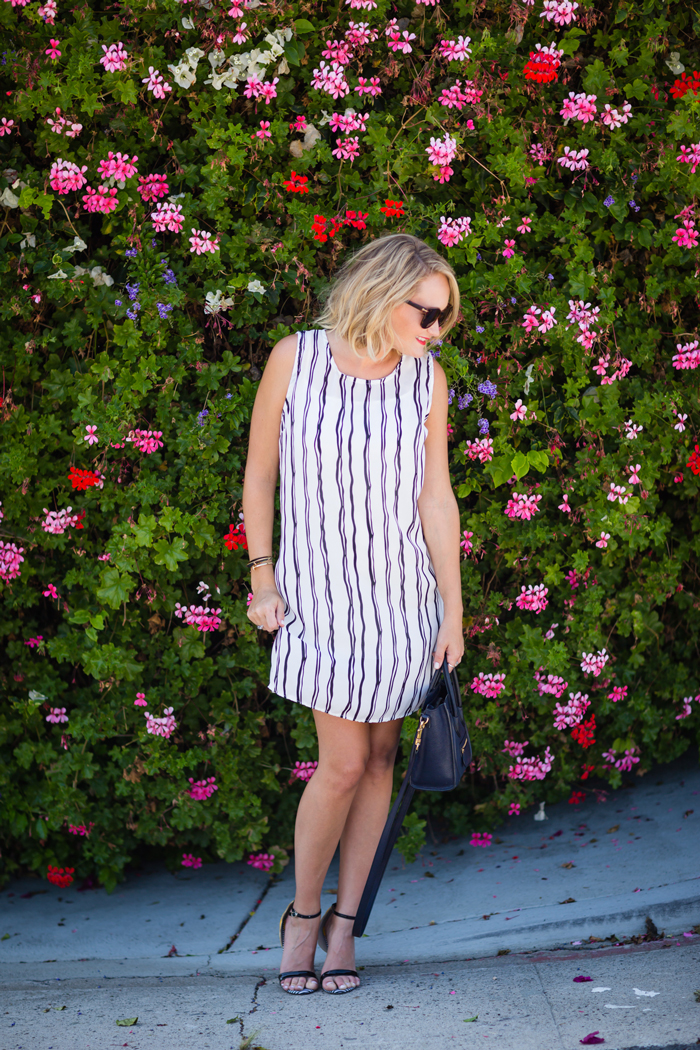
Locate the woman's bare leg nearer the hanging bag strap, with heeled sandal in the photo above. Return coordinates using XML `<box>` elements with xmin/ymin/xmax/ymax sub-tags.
<box><xmin>323</xmin><ymin>718</ymin><xmax>403</xmax><ymax>989</ymax></box>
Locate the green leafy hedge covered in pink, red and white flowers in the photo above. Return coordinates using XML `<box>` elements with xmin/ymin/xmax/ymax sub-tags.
<box><xmin>0</xmin><ymin>0</ymin><xmax>700</xmax><ymax>886</ymax></box>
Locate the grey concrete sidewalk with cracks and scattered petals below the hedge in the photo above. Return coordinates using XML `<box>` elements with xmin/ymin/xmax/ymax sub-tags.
<box><xmin>0</xmin><ymin>759</ymin><xmax>700</xmax><ymax>1050</ymax></box>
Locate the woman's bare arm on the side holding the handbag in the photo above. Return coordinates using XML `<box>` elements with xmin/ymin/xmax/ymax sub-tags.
<box><xmin>418</xmin><ymin>360</ymin><xmax>464</xmax><ymax>666</ymax></box>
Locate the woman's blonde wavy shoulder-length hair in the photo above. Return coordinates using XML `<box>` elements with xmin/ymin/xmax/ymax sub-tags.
<box><xmin>315</xmin><ymin>233</ymin><xmax>460</xmax><ymax>361</ymax></box>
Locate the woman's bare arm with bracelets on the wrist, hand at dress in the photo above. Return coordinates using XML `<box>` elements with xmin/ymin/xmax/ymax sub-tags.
<box><xmin>243</xmin><ymin>335</ymin><xmax>297</xmax><ymax>631</ymax></box>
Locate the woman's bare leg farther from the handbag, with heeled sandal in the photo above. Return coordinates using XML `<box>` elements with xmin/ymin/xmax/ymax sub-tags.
<box><xmin>281</xmin><ymin>711</ymin><xmax>373</xmax><ymax>988</ymax></box>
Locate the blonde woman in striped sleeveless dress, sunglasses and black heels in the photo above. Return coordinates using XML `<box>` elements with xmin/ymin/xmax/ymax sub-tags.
<box><xmin>243</xmin><ymin>234</ymin><xmax>464</xmax><ymax>994</ymax></box>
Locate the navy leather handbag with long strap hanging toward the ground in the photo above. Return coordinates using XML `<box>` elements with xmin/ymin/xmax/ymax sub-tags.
<box><xmin>353</xmin><ymin>657</ymin><xmax>471</xmax><ymax>937</ymax></box>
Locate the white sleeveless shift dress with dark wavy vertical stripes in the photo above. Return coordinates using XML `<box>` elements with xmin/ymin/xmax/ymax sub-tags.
<box><xmin>269</xmin><ymin>331</ymin><xmax>444</xmax><ymax>722</ymax></box>
